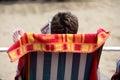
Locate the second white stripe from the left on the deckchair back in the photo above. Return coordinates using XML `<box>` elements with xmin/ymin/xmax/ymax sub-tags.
<box><xmin>50</xmin><ymin>53</ymin><xmax>59</xmax><ymax>80</ymax></box>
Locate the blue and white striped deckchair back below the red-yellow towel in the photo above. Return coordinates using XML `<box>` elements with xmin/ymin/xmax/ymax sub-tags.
<box><xmin>19</xmin><ymin>49</ymin><xmax>101</xmax><ymax>80</ymax></box>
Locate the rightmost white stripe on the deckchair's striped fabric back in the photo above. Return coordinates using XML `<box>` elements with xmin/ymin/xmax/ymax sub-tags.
<box><xmin>78</xmin><ymin>54</ymin><xmax>87</xmax><ymax>80</ymax></box>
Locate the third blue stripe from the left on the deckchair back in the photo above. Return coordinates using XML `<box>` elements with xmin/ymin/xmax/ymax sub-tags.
<box><xmin>57</xmin><ymin>53</ymin><xmax>66</xmax><ymax>80</ymax></box>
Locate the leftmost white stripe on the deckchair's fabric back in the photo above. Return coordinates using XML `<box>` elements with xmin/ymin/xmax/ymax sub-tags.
<box><xmin>36</xmin><ymin>52</ymin><xmax>44</xmax><ymax>80</ymax></box>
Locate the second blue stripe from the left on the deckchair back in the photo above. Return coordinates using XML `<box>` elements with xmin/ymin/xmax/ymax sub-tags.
<box><xmin>43</xmin><ymin>52</ymin><xmax>52</xmax><ymax>80</ymax></box>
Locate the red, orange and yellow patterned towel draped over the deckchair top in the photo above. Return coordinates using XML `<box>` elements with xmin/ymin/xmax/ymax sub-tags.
<box><xmin>7</xmin><ymin>29</ymin><xmax>110</xmax><ymax>61</ymax></box>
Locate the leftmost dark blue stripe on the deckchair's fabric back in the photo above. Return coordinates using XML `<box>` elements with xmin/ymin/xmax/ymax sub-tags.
<box><xmin>30</xmin><ymin>52</ymin><xmax>37</xmax><ymax>80</ymax></box>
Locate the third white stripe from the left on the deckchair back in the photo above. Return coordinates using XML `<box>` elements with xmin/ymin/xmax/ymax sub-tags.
<box><xmin>64</xmin><ymin>53</ymin><xmax>73</xmax><ymax>80</ymax></box>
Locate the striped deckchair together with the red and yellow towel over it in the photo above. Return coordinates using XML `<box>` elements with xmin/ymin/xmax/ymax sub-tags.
<box><xmin>7</xmin><ymin>29</ymin><xmax>110</xmax><ymax>80</ymax></box>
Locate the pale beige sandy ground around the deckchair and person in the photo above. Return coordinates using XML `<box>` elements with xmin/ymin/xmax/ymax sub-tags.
<box><xmin>0</xmin><ymin>0</ymin><xmax>120</xmax><ymax>80</ymax></box>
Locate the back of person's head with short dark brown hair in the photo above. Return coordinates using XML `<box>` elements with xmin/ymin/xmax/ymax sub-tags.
<box><xmin>51</xmin><ymin>12</ymin><xmax>78</xmax><ymax>34</ymax></box>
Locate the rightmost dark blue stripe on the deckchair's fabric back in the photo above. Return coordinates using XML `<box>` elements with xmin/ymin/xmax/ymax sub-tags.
<box><xmin>84</xmin><ymin>54</ymin><xmax>94</xmax><ymax>80</ymax></box>
